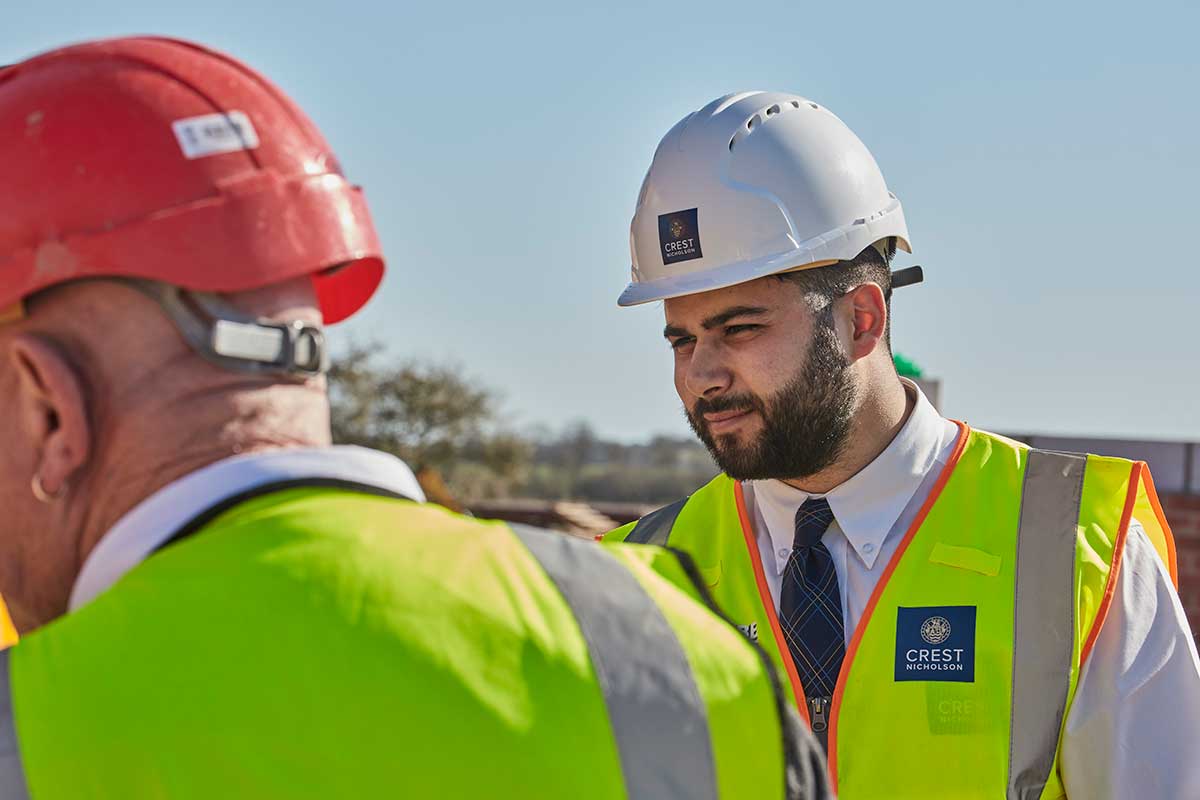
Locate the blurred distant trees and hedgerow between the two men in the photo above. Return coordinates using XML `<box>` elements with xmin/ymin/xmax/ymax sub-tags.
<box><xmin>329</xmin><ymin>344</ymin><xmax>716</xmax><ymax>507</ymax></box>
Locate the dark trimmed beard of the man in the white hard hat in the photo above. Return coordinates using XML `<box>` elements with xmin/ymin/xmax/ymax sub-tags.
<box><xmin>684</xmin><ymin>326</ymin><xmax>858</xmax><ymax>481</ymax></box>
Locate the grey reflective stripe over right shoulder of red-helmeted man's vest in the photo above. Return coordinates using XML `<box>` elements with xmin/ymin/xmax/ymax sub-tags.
<box><xmin>511</xmin><ymin>524</ymin><xmax>716</xmax><ymax>800</ymax></box>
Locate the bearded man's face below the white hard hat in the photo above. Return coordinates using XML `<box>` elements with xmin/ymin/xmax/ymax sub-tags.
<box><xmin>665</xmin><ymin>277</ymin><xmax>857</xmax><ymax>480</ymax></box>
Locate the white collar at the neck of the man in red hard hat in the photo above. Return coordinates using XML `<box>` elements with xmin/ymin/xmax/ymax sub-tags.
<box><xmin>70</xmin><ymin>446</ymin><xmax>425</xmax><ymax>610</ymax></box>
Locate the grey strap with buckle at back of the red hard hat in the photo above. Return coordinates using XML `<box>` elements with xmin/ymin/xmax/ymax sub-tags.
<box><xmin>122</xmin><ymin>278</ymin><xmax>329</xmax><ymax>379</ymax></box>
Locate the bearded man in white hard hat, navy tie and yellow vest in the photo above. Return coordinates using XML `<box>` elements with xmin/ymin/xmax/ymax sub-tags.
<box><xmin>606</xmin><ymin>92</ymin><xmax>1200</xmax><ymax>800</ymax></box>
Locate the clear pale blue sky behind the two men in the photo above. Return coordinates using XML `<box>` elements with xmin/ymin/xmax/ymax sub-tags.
<box><xmin>0</xmin><ymin>0</ymin><xmax>1200</xmax><ymax>440</ymax></box>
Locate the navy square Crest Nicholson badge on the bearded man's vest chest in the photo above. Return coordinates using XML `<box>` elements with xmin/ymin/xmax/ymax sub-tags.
<box><xmin>895</xmin><ymin>606</ymin><xmax>976</xmax><ymax>684</ymax></box>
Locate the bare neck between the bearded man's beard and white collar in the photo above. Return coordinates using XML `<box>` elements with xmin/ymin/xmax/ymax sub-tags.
<box><xmin>784</xmin><ymin>379</ymin><xmax>917</xmax><ymax>494</ymax></box>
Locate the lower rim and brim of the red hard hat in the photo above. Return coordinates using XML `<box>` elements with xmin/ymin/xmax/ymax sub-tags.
<box><xmin>0</xmin><ymin>174</ymin><xmax>384</xmax><ymax>325</ymax></box>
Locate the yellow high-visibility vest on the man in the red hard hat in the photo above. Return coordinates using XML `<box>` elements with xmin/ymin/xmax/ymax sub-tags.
<box><xmin>0</xmin><ymin>481</ymin><xmax>806</xmax><ymax>800</ymax></box>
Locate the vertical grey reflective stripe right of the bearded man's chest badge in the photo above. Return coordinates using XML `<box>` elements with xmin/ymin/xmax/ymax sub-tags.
<box><xmin>1008</xmin><ymin>450</ymin><xmax>1087</xmax><ymax>800</ymax></box>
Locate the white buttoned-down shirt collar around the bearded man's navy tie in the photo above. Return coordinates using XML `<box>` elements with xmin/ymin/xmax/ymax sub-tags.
<box><xmin>754</xmin><ymin>378</ymin><xmax>953</xmax><ymax>569</ymax></box>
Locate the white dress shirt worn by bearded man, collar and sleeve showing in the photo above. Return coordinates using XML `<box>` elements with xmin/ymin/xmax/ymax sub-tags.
<box><xmin>743</xmin><ymin>381</ymin><xmax>1200</xmax><ymax>800</ymax></box>
